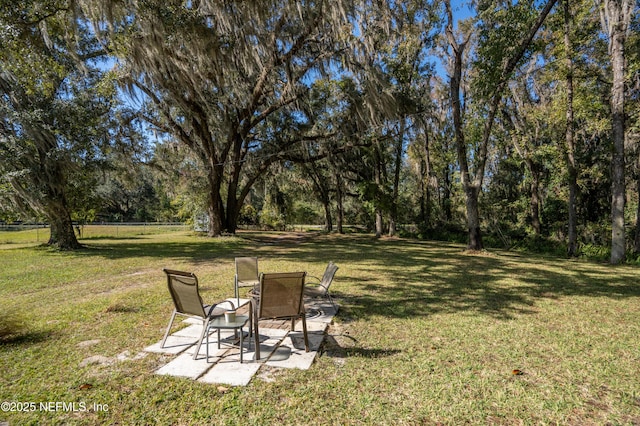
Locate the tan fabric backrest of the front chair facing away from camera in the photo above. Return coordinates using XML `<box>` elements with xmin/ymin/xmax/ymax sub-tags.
<box><xmin>257</xmin><ymin>272</ymin><xmax>307</xmax><ymax>318</ymax></box>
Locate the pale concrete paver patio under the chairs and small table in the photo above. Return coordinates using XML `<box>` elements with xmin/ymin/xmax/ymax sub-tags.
<box><xmin>144</xmin><ymin>299</ymin><xmax>336</xmax><ymax>386</ymax></box>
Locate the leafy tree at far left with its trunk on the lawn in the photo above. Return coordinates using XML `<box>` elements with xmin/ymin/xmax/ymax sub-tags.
<box><xmin>0</xmin><ymin>1</ymin><xmax>117</xmax><ymax>249</ymax></box>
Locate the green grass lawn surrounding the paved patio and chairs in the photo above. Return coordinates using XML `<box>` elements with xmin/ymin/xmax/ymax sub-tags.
<box><xmin>0</xmin><ymin>231</ymin><xmax>640</xmax><ymax>425</ymax></box>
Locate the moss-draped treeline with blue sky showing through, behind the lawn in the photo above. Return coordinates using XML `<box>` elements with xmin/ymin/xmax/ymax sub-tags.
<box><xmin>0</xmin><ymin>0</ymin><xmax>640</xmax><ymax>263</ymax></box>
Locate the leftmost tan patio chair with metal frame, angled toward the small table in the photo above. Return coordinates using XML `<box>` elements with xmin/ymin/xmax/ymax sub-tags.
<box><xmin>160</xmin><ymin>269</ymin><xmax>235</xmax><ymax>359</ymax></box>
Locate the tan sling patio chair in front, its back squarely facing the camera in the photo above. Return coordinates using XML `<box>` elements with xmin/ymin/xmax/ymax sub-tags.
<box><xmin>253</xmin><ymin>272</ymin><xmax>309</xmax><ymax>361</ymax></box>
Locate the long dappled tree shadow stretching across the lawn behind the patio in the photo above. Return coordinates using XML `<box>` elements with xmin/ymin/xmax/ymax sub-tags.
<box><xmin>37</xmin><ymin>233</ymin><xmax>640</xmax><ymax>319</ymax></box>
